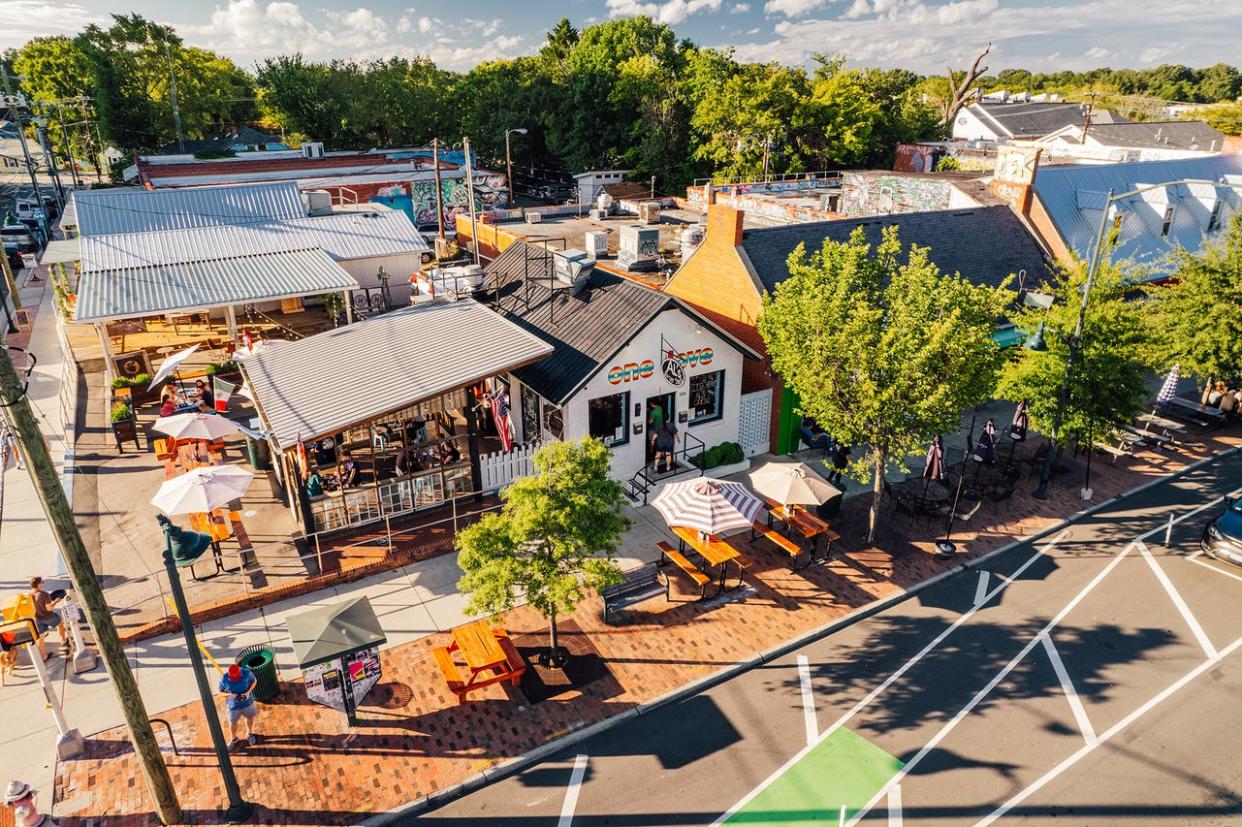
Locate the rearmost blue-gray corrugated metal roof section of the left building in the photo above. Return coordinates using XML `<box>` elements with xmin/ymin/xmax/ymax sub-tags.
<box><xmin>72</xmin><ymin>181</ymin><xmax>307</xmax><ymax>236</ymax></box>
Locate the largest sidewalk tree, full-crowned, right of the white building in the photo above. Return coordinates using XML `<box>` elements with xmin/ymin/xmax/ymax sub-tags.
<box><xmin>759</xmin><ymin>227</ymin><xmax>1012</xmax><ymax>543</ymax></box>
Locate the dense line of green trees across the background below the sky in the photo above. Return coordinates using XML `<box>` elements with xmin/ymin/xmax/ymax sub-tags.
<box><xmin>5</xmin><ymin>15</ymin><xmax>1242</xmax><ymax>191</ymax></box>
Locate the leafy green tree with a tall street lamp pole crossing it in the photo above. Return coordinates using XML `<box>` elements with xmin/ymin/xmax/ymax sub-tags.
<box><xmin>997</xmin><ymin>260</ymin><xmax>1148</xmax><ymax>459</ymax></box>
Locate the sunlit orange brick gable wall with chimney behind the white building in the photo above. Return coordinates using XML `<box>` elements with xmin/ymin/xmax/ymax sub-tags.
<box><xmin>664</xmin><ymin>204</ymin><xmax>781</xmax><ymax>446</ymax></box>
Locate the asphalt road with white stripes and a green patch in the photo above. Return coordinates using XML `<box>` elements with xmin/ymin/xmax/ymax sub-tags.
<box><xmin>410</xmin><ymin>447</ymin><xmax>1242</xmax><ymax>827</ymax></box>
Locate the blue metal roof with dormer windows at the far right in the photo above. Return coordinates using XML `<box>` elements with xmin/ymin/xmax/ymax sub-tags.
<box><xmin>1035</xmin><ymin>155</ymin><xmax>1242</xmax><ymax>274</ymax></box>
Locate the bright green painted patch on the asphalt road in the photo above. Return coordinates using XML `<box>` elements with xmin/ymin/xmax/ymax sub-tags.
<box><xmin>724</xmin><ymin>726</ymin><xmax>903</xmax><ymax>827</ymax></box>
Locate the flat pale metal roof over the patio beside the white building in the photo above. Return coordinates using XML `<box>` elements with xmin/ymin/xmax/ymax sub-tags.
<box><xmin>242</xmin><ymin>301</ymin><xmax>553</xmax><ymax>451</ymax></box>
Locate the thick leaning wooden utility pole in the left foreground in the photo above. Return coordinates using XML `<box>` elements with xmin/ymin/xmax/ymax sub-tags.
<box><xmin>0</xmin><ymin>348</ymin><xmax>181</xmax><ymax>825</ymax></box>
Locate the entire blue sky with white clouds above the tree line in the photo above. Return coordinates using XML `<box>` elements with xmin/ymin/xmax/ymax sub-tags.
<box><xmin>0</xmin><ymin>0</ymin><xmax>1242</xmax><ymax>73</ymax></box>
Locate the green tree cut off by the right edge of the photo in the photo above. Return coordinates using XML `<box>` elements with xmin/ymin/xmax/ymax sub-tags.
<box><xmin>1146</xmin><ymin>214</ymin><xmax>1242</xmax><ymax>380</ymax></box>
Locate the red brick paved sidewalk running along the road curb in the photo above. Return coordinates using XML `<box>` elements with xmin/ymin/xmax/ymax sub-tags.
<box><xmin>56</xmin><ymin>424</ymin><xmax>1242</xmax><ymax>823</ymax></box>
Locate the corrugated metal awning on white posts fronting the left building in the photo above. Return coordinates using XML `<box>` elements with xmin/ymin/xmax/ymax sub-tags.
<box><xmin>76</xmin><ymin>250</ymin><xmax>358</xmax><ymax>322</ymax></box>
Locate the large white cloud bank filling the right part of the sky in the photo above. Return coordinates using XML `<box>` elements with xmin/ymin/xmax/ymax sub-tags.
<box><xmin>722</xmin><ymin>0</ymin><xmax>1242</xmax><ymax>73</ymax></box>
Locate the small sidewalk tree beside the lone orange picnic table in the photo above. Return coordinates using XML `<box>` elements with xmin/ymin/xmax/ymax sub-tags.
<box><xmin>457</xmin><ymin>437</ymin><xmax>630</xmax><ymax>666</ymax></box>
